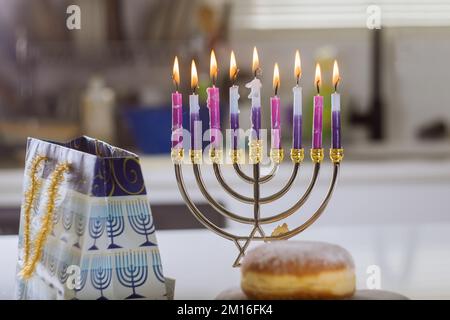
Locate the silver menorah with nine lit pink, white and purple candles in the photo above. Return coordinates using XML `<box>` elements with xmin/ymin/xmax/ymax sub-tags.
<box><xmin>171</xmin><ymin>47</ymin><xmax>344</xmax><ymax>267</ymax></box>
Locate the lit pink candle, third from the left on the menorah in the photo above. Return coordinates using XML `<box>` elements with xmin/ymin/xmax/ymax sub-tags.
<box><xmin>206</xmin><ymin>50</ymin><xmax>222</xmax><ymax>149</ymax></box>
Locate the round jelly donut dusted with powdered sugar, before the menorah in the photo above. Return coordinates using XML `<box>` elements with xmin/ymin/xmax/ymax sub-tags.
<box><xmin>241</xmin><ymin>241</ymin><xmax>355</xmax><ymax>299</ymax></box>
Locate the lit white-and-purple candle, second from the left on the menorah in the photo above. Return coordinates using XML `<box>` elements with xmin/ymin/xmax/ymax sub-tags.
<box><xmin>189</xmin><ymin>60</ymin><xmax>202</xmax><ymax>150</ymax></box>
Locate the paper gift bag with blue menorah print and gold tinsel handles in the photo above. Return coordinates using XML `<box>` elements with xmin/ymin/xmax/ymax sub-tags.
<box><xmin>16</xmin><ymin>137</ymin><xmax>167</xmax><ymax>300</ymax></box>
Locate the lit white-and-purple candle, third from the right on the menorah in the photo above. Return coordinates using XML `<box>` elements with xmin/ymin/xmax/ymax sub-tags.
<box><xmin>292</xmin><ymin>50</ymin><xmax>302</xmax><ymax>149</ymax></box>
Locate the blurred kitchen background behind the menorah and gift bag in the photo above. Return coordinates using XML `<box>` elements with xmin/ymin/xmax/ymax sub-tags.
<box><xmin>0</xmin><ymin>0</ymin><xmax>450</xmax><ymax>296</ymax></box>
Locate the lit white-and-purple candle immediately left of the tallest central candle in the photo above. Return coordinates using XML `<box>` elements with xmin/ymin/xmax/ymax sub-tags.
<box><xmin>230</xmin><ymin>51</ymin><xmax>239</xmax><ymax>150</ymax></box>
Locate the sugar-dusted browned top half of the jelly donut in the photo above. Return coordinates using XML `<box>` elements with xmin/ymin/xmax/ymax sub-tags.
<box><xmin>242</xmin><ymin>241</ymin><xmax>354</xmax><ymax>273</ymax></box>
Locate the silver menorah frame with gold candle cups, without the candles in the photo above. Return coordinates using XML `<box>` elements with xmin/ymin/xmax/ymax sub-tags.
<box><xmin>171</xmin><ymin>139</ymin><xmax>344</xmax><ymax>267</ymax></box>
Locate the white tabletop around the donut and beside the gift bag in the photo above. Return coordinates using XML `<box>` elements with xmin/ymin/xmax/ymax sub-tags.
<box><xmin>0</xmin><ymin>221</ymin><xmax>450</xmax><ymax>299</ymax></box>
